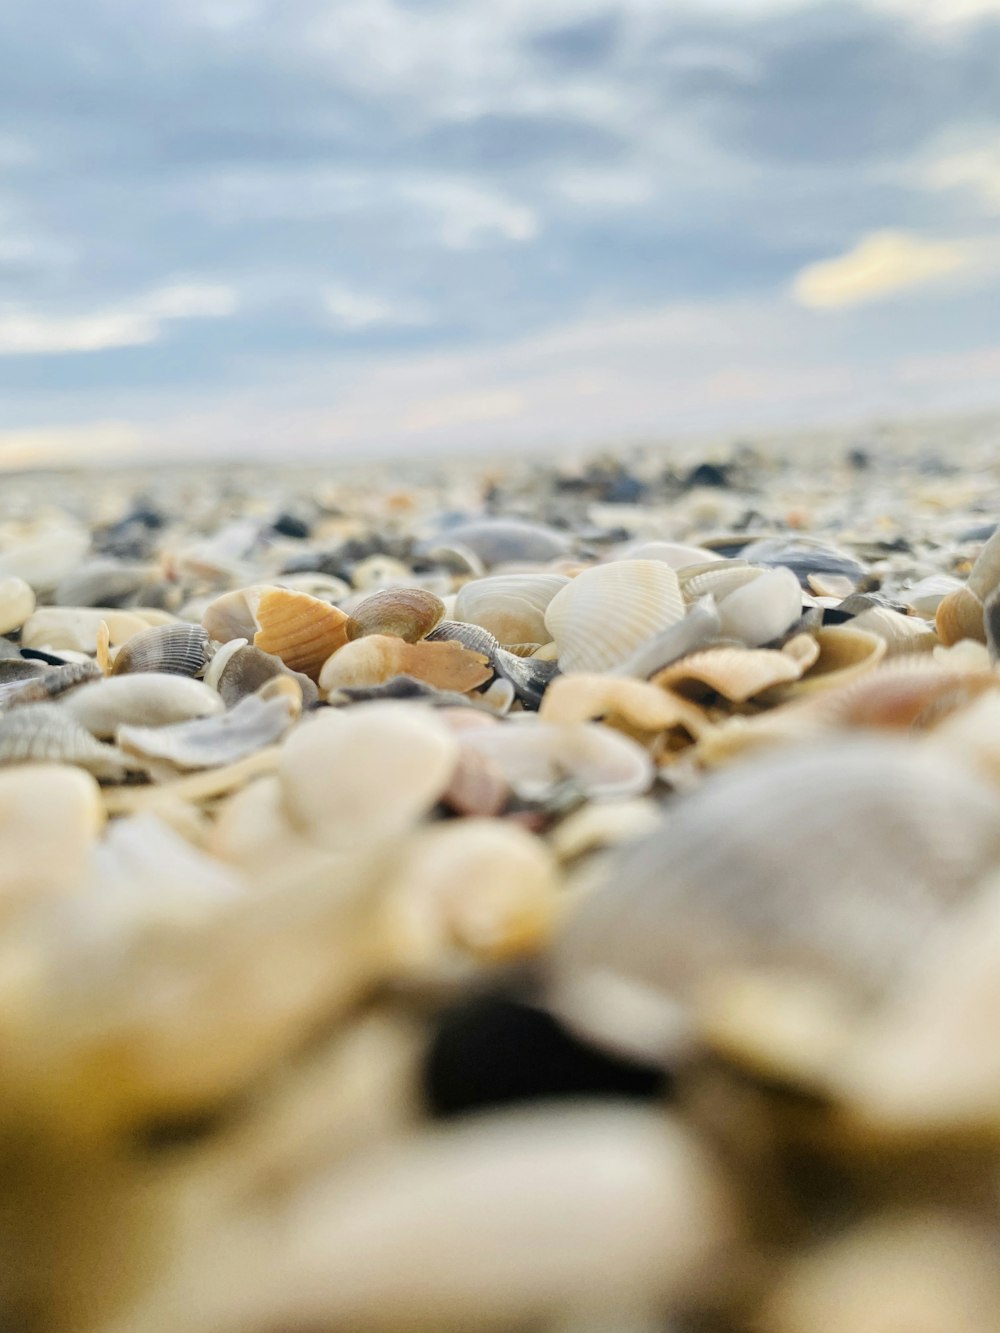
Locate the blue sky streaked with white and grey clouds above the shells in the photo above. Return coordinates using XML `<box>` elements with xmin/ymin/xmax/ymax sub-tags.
<box><xmin>0</xmin><ymin>0</ymin><xmax>1000</xmax><ymax>467</ymax></box>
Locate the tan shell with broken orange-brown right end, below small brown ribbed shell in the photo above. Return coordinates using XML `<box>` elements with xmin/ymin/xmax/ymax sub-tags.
<box><xmin>319</xmin><ymin>635</ymin><xmax>493</xmax><ymax>694</ymax></box>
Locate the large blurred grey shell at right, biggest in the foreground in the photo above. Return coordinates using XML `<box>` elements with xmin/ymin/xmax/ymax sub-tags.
<box><xmin>552</xmin><ymin>738</ymin><xmax>1000</xmax><ymax>1069</ymax></box>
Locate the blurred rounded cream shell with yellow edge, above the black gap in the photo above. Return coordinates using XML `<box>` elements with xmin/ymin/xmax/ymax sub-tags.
<box><xmin>387</xmin><ymin>817</ymin><xmax>560</xmax><ymax>970</ymax></box>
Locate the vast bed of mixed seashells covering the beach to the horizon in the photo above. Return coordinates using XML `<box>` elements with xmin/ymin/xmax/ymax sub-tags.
<box><xmin>0</xmin><ymin>444</ymin><xmax>1000</xmax><ymax>1333</ymax></box>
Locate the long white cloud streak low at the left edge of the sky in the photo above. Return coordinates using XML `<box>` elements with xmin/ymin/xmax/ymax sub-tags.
<box><xmin>0</xmin><ymin>283</ymin><xmax>236</xmax><ymax>356</ymax></box>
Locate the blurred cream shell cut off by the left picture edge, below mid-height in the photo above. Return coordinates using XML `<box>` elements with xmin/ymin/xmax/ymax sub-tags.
<box><xmin>0</xmin><ymin>764</ymin><xmax>104</xmax><ymax>916</ymax></box>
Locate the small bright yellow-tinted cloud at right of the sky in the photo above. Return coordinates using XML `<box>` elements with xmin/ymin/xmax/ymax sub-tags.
<box><xmin>792</xmin><ymin>231</ymin><xmax>973</xmax><ymax>311</ymax></box>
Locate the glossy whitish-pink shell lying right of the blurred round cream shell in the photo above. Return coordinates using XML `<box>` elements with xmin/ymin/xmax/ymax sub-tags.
<box><xmin>463</xmin><ymin>721</ymin><xmax>653</xmax><ymax>802</ymax></box>
